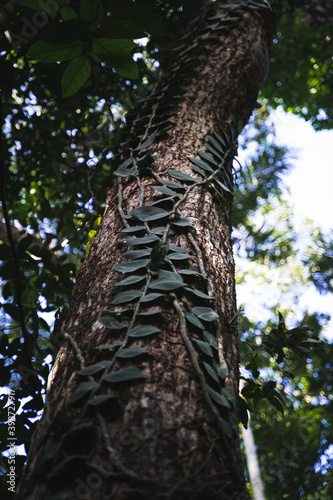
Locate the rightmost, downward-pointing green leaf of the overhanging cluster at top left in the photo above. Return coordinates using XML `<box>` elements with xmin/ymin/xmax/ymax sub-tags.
<box><xmin>91</xmin><ymin>38</ymin><xmax>139</xmax><ymax>78</ymax></box>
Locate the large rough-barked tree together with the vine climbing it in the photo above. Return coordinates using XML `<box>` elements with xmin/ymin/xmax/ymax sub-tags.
<box><xmin>0</xmin><ymin>1</ymin><xmax>330</xmax><ymax>500</ymax></box>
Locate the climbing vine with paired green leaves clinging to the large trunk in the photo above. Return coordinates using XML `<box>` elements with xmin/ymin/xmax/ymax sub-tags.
<box><xmin>33</xmin><ymin>0</ymin><xmax>269</xmax><ymax>492</ymax></box>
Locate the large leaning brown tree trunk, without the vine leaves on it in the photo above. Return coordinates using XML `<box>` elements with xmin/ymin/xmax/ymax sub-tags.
<box><xmin>16</xmin><ymin>2</ymin><xmax>270</xmax><ymax>500</ymax></box>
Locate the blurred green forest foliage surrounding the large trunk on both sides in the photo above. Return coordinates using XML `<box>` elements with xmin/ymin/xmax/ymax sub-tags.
<box><xmin>0</xmin><ymin>0</ymin><xmax>333</xmax><ymax>500</ymax></box>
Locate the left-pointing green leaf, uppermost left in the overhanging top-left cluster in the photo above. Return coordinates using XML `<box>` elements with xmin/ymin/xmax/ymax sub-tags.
<box><xmin>27</xmin><ymin>40</ymin><xmax>84</xmax><ymax>63</ymax></box>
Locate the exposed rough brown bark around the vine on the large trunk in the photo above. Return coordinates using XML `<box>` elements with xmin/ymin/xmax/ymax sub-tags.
<box><xmin>16</xmin><ymin>4</ymin><xmax>270</xmax><ymax>500</ymax></box>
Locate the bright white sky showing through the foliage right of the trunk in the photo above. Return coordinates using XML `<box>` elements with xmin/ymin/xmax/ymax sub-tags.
<box><xmin>235</xmin><ymin>108</ymin><xmax>333</xmax><ymax>341</ymax></box>
